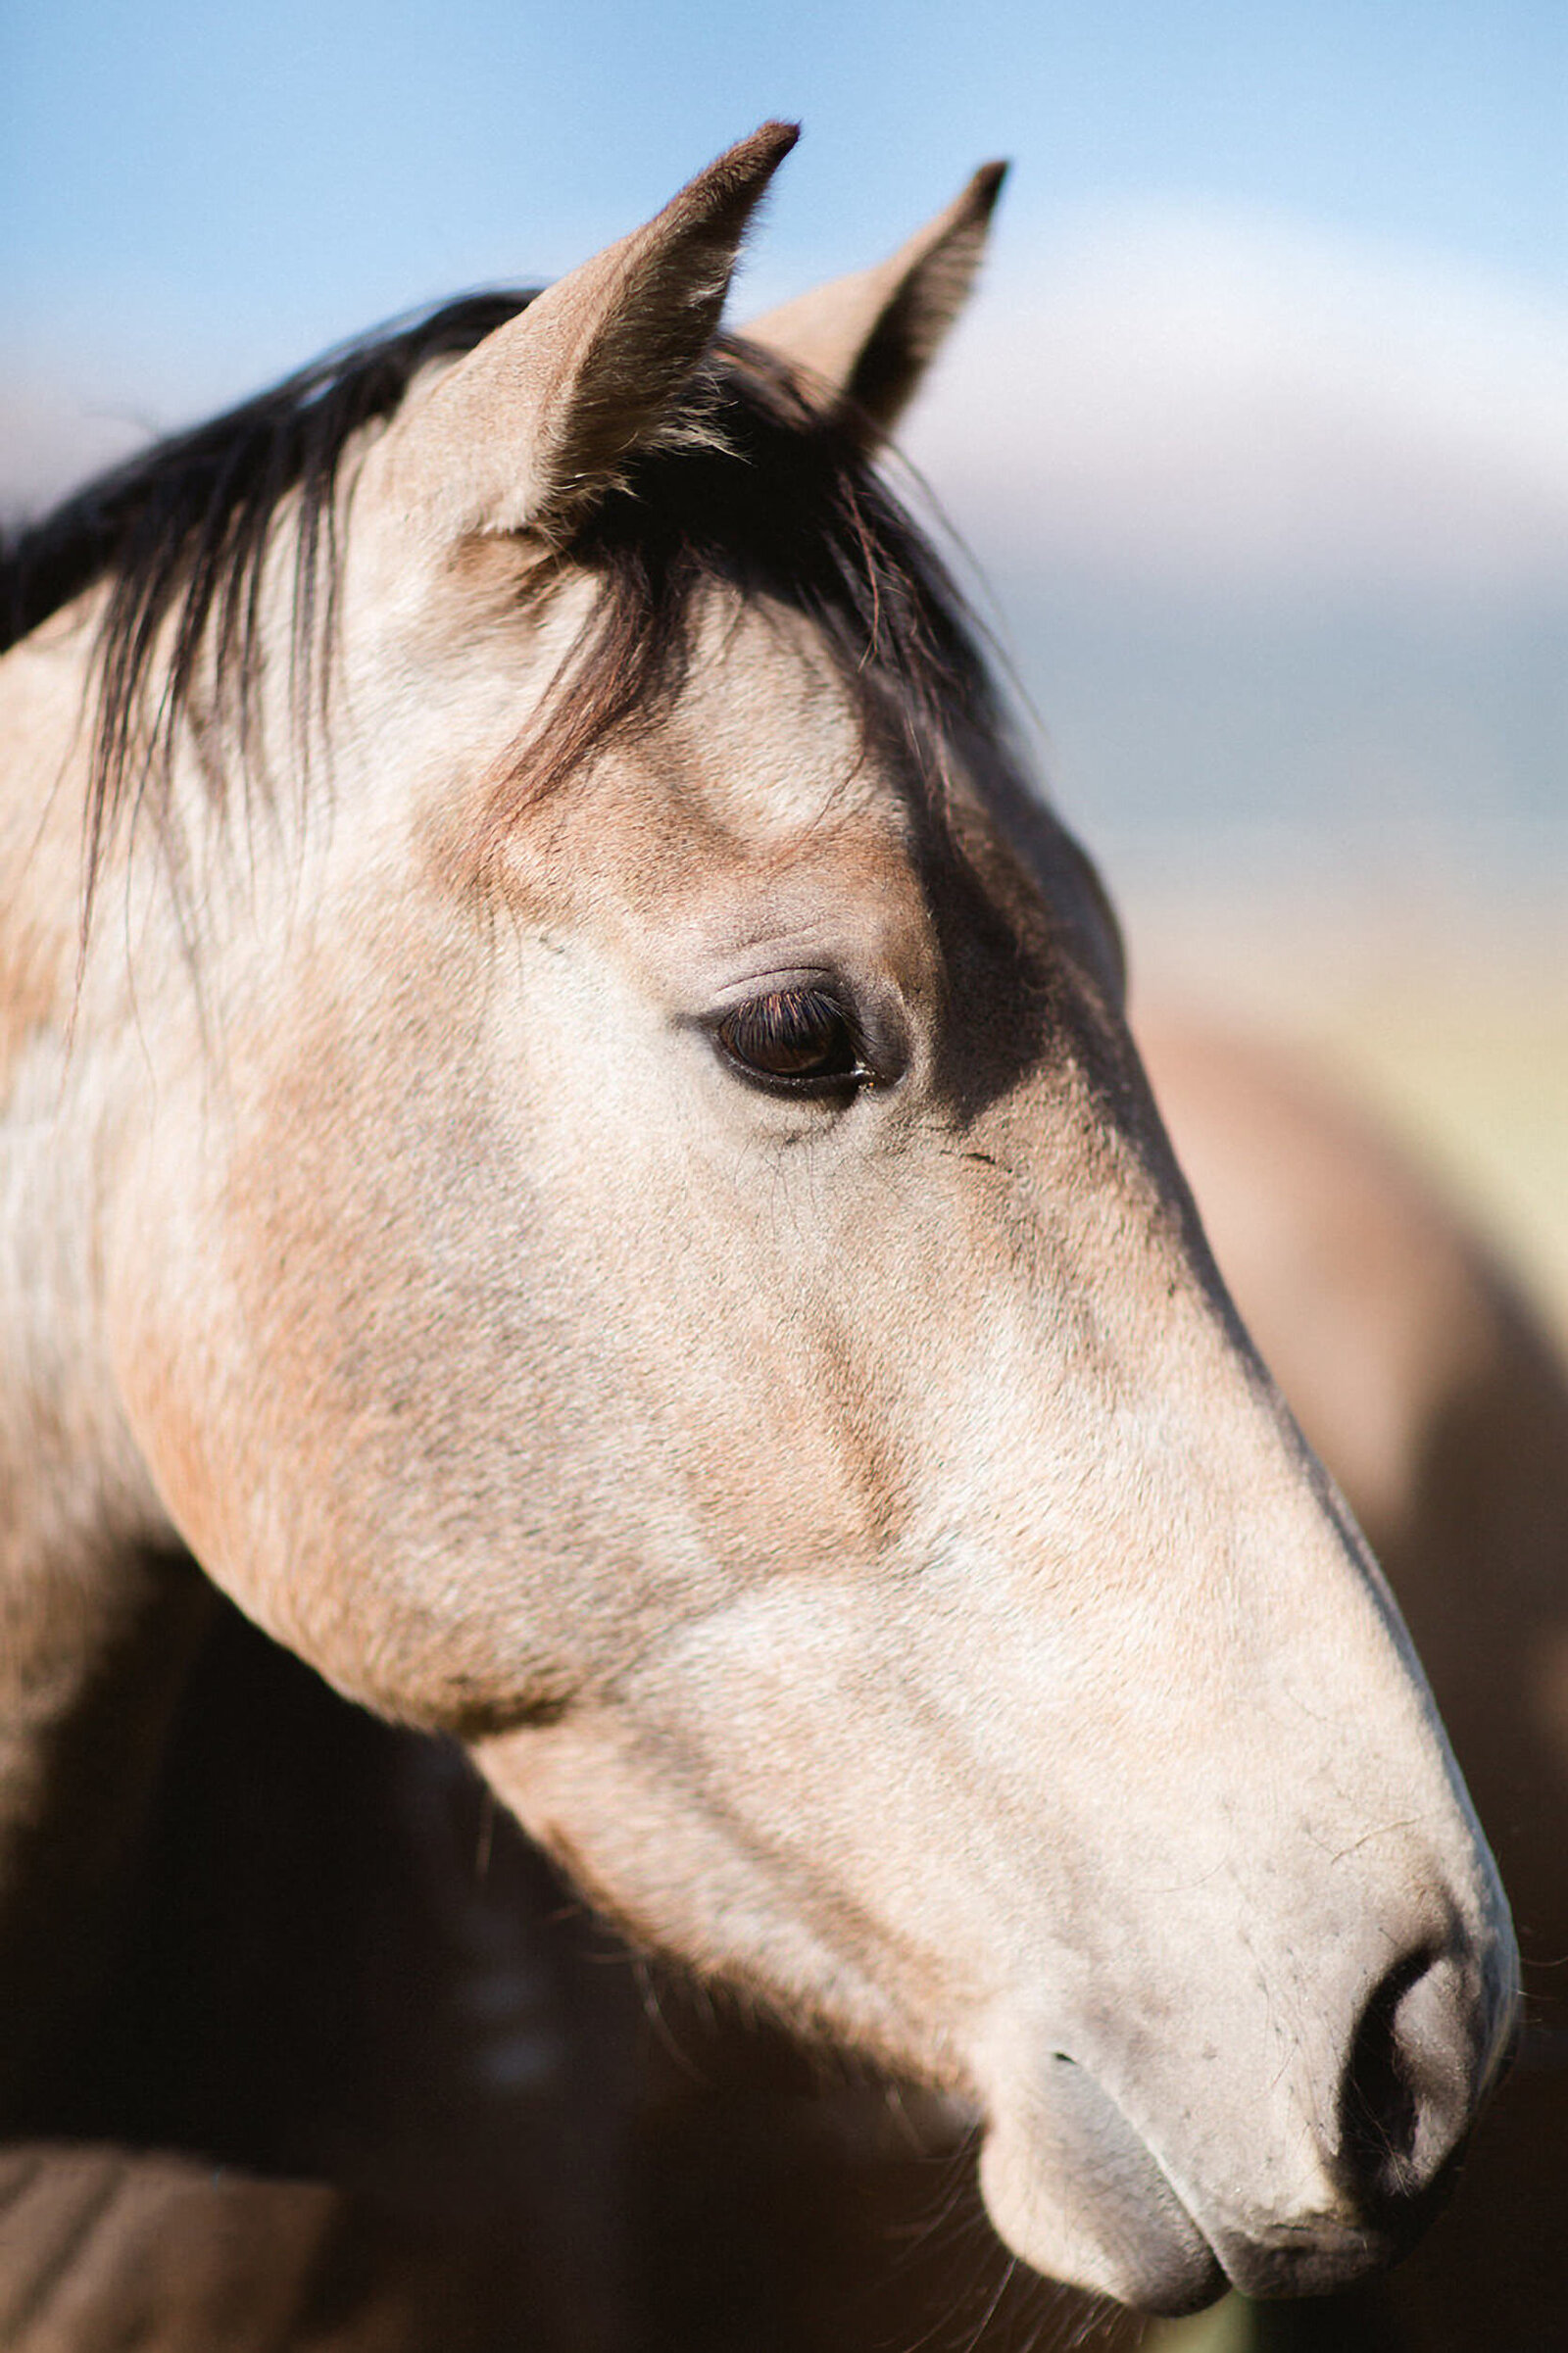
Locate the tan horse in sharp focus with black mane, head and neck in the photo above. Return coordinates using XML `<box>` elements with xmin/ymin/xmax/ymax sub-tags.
<box><xmin>0</xmin><ymin>124</ymin><xmax>1516</xmax><ymax>2313</ymax></box>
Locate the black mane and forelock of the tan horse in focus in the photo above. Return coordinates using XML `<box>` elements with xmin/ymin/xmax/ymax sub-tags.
<box><xmin>0</xmin><ymin>292</ymin><xmax>991</xmax><ymax>897</ymax></box>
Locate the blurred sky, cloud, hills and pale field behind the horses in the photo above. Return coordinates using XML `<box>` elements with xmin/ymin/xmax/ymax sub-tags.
<box><xmin>0</xmin><ymin>0</ymin><xmax>1568</xmax><ymax>1320</ymax></box>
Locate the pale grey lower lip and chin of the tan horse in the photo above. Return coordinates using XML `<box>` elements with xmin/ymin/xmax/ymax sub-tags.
<box><xmin>979</xmin><ymin>2056</ymin><xmax>1227</xmax><ymax>2318</ymax></box>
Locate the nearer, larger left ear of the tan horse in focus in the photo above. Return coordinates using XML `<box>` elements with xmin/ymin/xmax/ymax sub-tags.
<box><xmin>386</xmin><ymin>123</ymin><xmax>798</xmax><ymax>539</ymax></box>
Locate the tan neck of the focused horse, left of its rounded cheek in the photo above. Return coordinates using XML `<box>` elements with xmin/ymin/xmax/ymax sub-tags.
<box><xmin>0</xmin><ymin>602</ymin><xmax>200</xmax><ymax>2123</ymax></box>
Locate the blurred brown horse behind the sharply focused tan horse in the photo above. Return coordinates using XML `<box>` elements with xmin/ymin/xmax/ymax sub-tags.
<box><xmin>0</xmin><ymin>1003</ymin><xmax>1568</xmax><ymax>2353</ymax></box>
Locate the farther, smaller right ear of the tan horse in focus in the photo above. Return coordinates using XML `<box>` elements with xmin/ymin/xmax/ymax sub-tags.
<box><xmin>747</xmin><ymin>163</ymin><xmax>1007</xmax><ymax>442</ymax></box>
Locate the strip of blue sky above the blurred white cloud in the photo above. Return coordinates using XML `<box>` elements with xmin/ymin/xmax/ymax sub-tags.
<box><xmin>0</xmin><ymin>0</ymin><xmax>1568</xmax><ymax>371</ymax></box>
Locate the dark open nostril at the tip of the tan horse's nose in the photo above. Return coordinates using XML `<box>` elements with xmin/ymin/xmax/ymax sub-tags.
<box><xmin>1340</xmin><ymin>1946</ymin><xmax>1476</xmax><ymax>2235</ymax></box>
